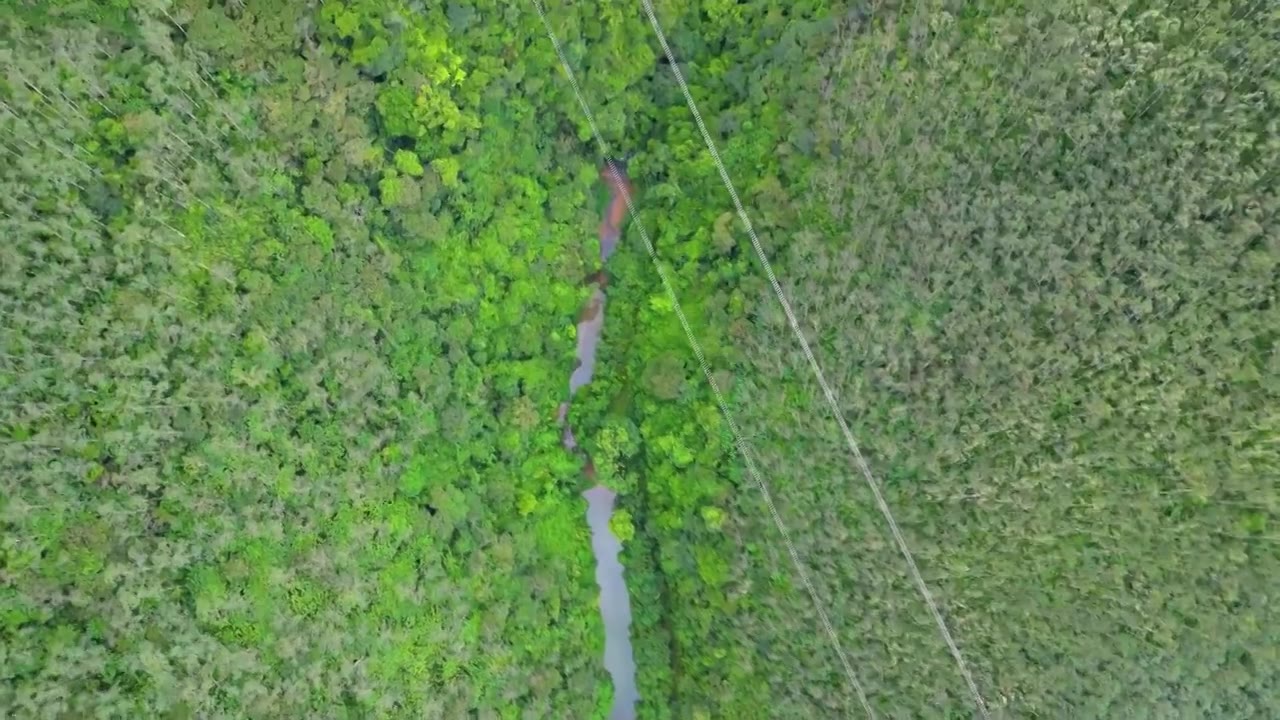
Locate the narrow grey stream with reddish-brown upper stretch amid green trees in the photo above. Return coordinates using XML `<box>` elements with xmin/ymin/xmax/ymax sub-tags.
<box><xmin>559</xmin><ymin>161</ymin><xmax>640</xmax><ymax>720</ymax></box>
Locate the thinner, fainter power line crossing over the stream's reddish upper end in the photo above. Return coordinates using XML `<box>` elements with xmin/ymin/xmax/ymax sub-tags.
<box><xmin>531</xmin><ymin>0</ymin><xmax>876</xmax><ymax>720</ymax></box>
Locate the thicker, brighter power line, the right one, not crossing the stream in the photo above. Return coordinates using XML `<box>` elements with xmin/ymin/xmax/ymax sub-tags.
<box><xmin>641</xmin><ymin>0</ymin><xmax>991</xmax><ymax>720</ymax></box>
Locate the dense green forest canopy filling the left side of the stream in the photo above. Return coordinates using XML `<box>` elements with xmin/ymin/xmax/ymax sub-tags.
<box><xmin>0</xmin><ymin>3</ymin><xmax>607</xmax><ymax>717</ymax></box>
